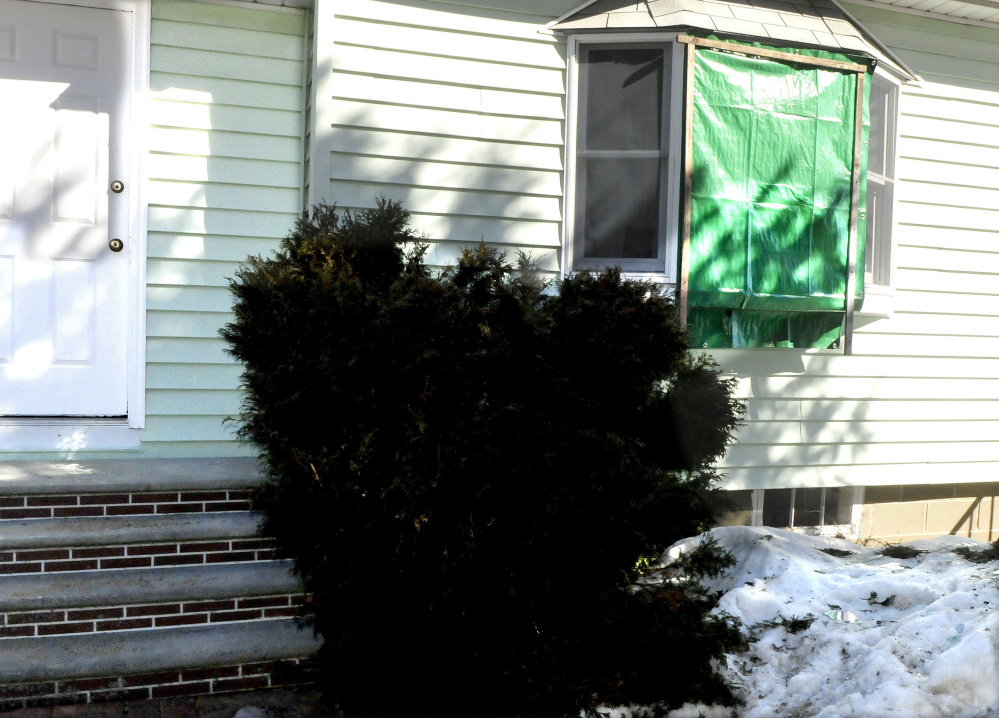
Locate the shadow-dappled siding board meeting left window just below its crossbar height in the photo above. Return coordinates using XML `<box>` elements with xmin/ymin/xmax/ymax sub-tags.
<box><xmin>332</xmin><ymin>154</ymin><xmax>562</xmax><ymax>200</ymax></box>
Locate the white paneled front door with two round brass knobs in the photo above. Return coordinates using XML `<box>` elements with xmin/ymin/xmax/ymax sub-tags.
<box><xmin>0</xmin><ymin>0</ymin><xmax>132</xmax><ymax>416</ymax></box>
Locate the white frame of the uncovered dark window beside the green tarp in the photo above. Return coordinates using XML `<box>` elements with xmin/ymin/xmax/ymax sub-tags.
<box><xmin>562</xmin><ymin>32</ymin><xmax>685</xmax><ymax>284</ymax></box>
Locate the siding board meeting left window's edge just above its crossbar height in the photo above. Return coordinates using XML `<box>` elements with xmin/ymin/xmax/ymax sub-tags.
<box><xmin>330</xmin><ymin>100</ymin><xmax>562</xmax><ymax>146</ymax></box>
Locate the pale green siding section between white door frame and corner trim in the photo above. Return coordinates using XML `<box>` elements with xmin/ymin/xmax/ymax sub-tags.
<box><xmin>142</xmin><ymin>0</ymin><xmax>306</xmax><ymax>457</ymax></box>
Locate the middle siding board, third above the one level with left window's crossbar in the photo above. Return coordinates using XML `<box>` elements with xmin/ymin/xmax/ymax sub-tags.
<box><xmin>332</xmin><ymin>45</ymin><xmax>565</xmax><ymax>95</ymax></box>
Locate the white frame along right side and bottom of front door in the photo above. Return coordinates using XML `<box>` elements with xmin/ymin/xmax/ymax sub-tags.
<box><xmin>0</xmin><ymin>0</ymin><xmax>152</xmax><ymax>454</ymax></box>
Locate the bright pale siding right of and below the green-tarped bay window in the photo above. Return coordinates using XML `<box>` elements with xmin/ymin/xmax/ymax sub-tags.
<box><xmin>715</xmin><ymin>6</ymin><xmax>999</xmax><ymax>496</ymax></box>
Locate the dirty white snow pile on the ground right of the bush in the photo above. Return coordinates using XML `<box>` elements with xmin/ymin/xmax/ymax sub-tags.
<box><xmin>668</xmin><ymin>527</ymin><xmax>999</xmax><ymax>718</ymax></box>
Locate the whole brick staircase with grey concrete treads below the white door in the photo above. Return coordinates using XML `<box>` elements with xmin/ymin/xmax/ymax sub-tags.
<box><xmin>0</xmin><ymin>459</ymin><xmax>319</xmax><ymax>711</ymax></box>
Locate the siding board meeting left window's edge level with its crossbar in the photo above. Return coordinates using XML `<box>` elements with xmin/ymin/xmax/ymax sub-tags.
<box><xmin>333</xmin><ymin>127</ymin><xmax>562</xmax><ymax>172</ymax></box>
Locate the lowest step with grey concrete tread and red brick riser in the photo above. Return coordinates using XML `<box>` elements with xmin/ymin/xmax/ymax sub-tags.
<box><xmin>0</xmin><ymin>618</ymin><xmax>319</xmax><ymax>710</ymax></box>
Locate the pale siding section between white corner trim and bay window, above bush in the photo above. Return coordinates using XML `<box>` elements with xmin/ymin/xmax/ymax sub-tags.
<box><xmin>324</xmin><ymin>0</ymin><xmax>565</xmax><ymax>272</ymax></box>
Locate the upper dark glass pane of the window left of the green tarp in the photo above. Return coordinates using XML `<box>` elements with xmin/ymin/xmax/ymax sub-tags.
<box><xmin>584</xmin><ymin>48</ymin><xmax>663</xmax><ymax>150</ymax></box>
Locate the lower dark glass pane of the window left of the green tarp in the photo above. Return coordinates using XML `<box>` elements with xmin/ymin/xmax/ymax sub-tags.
<box><xmin>580</xmin><ymin>159</ymin><xmax>659</xmax><ymax>258</ymax></box>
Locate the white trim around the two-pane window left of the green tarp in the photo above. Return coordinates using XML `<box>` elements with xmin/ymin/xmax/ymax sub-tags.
<box><xmin>561</xmin><ymin>32</ymin><xmax>684</xmax><ymax>284</ymax></box>
